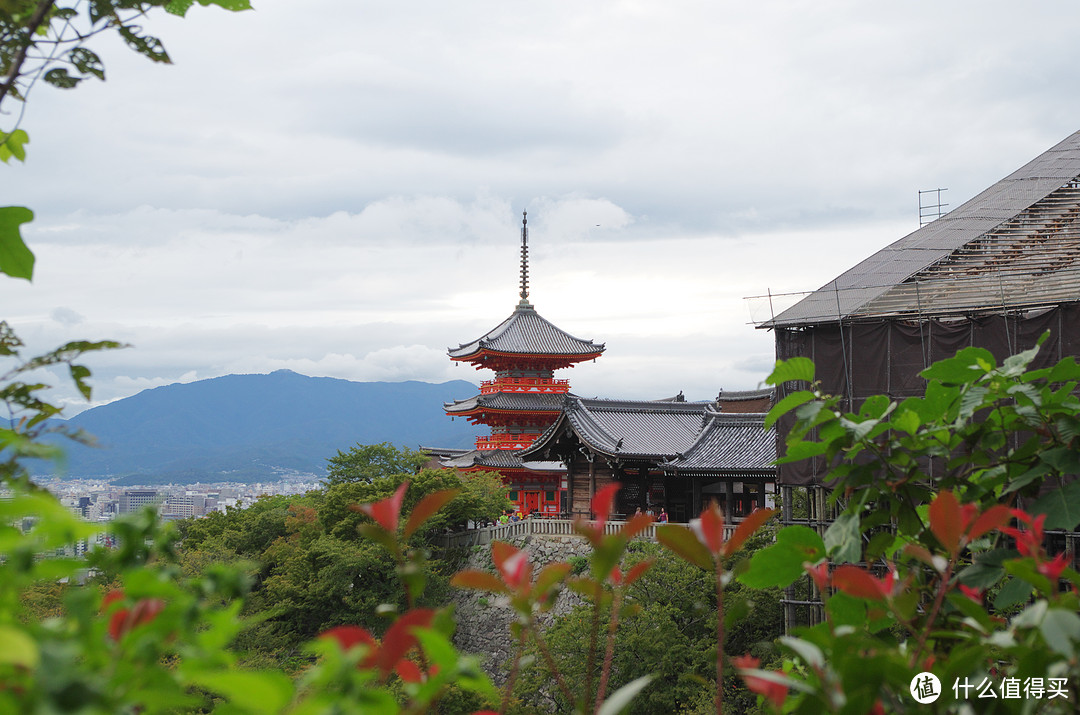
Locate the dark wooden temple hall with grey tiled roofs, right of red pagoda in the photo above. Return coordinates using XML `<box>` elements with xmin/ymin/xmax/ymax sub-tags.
<box><xmin>519</xmin><ymin>390</ymin><xmax>777</xmax><ymax>522</ymax></box>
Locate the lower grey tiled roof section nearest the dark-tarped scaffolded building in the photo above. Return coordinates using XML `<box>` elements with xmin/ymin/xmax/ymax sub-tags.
<box><xmin>661</xmin><ymin>409</ymin><xmax>777</xmax><ymax>475</ymax></box>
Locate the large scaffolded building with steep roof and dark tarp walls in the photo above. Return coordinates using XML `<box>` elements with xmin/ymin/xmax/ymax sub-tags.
<box><xmin>757</xmin><ymin>132</ymin><xmax>1080</xmax><ymax>635</ymax></box>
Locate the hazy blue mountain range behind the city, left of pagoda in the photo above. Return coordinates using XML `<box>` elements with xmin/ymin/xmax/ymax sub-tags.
<box><xmin>35</xmin><ymin>370</ymin><xmax>480</xmax><ymax>484</ymax></box>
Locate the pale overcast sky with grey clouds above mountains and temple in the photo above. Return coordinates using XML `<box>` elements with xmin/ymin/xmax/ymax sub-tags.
<box><xmin>6</xmin><ymin>0</ymin><xmax>1080</xmax><ymax>416</ymax></box>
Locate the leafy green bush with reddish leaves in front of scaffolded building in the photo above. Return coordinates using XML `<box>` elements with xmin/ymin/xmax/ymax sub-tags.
<box><xmin>740</xmin><ymin>341</ymin><xmax>1080</xmax><ymax>714</ymax></box>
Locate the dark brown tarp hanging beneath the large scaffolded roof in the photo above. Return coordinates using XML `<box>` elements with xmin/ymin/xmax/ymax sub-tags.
<box><xmin>777</xmin><ymin>302</ymin><xmax>1080</xmax><ymax>485</ymax></box>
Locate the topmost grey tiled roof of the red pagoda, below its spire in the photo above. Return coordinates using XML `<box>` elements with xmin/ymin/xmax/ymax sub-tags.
<box><xmin>448</xmin><ymin>303</ymin><xmax>604</xmax><ymax>359</ymax></box>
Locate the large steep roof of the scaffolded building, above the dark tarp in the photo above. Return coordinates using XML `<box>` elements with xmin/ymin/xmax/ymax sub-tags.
<box><xmin>759</xmin><ymin>132</ymin><xmax>1080</xmax><ymax>327</ymax></box>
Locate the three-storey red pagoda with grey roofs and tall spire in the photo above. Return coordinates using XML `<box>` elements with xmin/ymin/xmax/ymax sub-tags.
<box><xmin>443</xmin><ymin>213</ymin><xmax>604</xmax><ymax>514</ymax></box>
